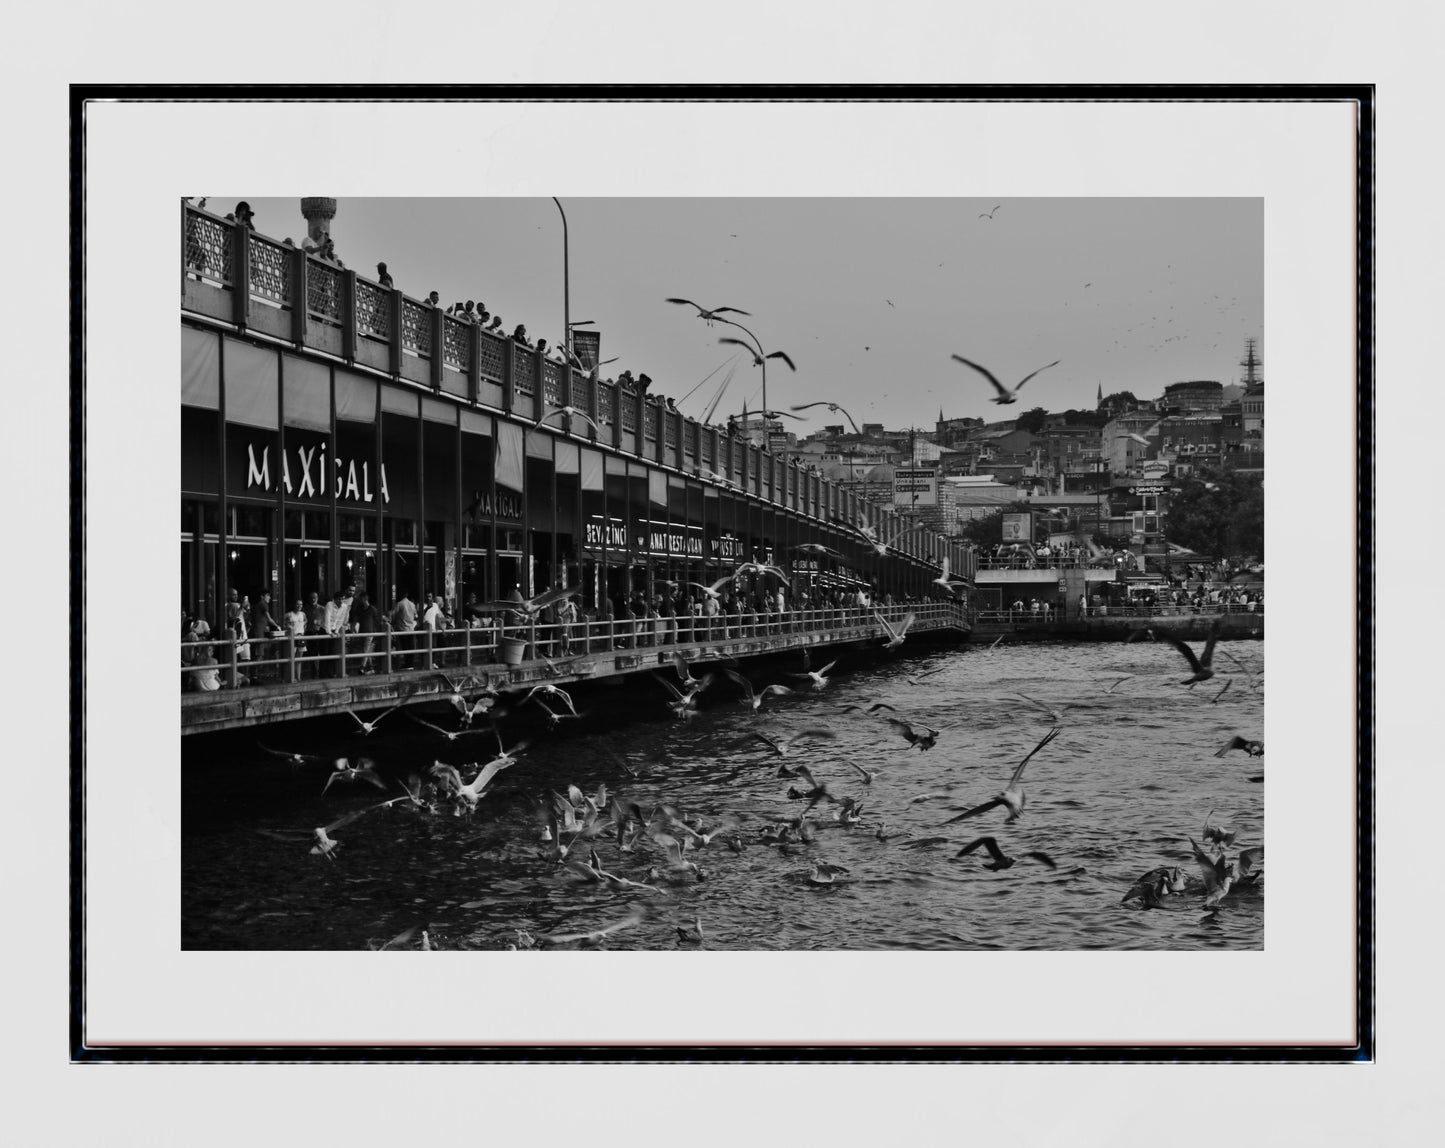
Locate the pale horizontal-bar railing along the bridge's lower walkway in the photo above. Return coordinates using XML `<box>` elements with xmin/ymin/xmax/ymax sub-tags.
<box><xmin>181</xmin><ymin>601</ymin><xmax>965</xmax><ymax>693</ymax></box>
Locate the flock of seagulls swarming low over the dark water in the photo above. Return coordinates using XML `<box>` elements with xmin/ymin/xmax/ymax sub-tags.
<box><xmin>242</xmin><ymin>596</ymin><xmax>1264</xmax><ymax>951</ymax></box>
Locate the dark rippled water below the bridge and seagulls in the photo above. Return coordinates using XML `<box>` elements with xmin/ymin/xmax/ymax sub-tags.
<box><xmin>182</xmin><ymin>641</ymin><xmax>1264</xmax><ymax>950</ymax></box>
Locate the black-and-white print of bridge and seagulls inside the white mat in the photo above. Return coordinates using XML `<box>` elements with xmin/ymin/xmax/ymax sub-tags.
<box><xmin>173</xmin><ymin>195</ymin><xmax>1269</xmax><ymax>953</ymax></box>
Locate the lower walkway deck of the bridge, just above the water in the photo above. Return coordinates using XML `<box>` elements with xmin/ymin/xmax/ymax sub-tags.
<box><xmin>181</xmin><ymin>601</ymin><xmax>970</xmax><ymax>734</ymax></box>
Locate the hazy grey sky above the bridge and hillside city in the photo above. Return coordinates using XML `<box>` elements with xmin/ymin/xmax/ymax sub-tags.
<box><xmin>231</xmin><ymin>197</ymin><xmax>1264</xmax><ymax>435</ymax></box>
